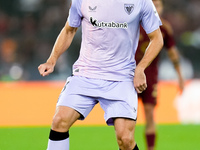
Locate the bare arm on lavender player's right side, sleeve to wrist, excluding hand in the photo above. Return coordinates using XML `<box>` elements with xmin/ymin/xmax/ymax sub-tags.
<box><xmin>136</xmin><ymin>29</ymin><xmax>163</xmax><ymax>71</ymax></box>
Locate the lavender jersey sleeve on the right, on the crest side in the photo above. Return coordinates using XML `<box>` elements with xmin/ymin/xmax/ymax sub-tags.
<box><xmin>141</xmin><ymin>0</ymin><xmax>162</xmax><ymax>34</ymax></box>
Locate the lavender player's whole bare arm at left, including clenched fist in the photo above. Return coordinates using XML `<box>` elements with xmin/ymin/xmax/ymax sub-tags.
<box><xmin>38</xmin><ymin>22</ymin><xmax>77</xmax><ymax>77</ymax></box>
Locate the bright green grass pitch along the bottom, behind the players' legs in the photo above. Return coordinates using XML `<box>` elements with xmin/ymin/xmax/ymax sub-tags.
<box><xmin>0</xmin><ymin>125</ymin><xmax>200</xmax><ymax>150</ymax></box>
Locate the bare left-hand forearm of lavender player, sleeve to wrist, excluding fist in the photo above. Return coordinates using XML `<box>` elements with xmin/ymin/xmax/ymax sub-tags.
<box><xmin>47</xmin><ymin>24</ymin><xmax>77</xmax><ymax>65</ymax></box>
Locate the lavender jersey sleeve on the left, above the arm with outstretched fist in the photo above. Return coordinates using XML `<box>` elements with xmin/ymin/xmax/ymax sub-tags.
<box><xmin>67</xmin><ymin>0</ymin><xmax>82</xmax><ymax>27</ymax></box>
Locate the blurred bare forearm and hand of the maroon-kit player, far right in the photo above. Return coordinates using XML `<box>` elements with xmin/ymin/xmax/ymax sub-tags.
<box><xmin>167</xmin><ymin>46</ymin><xmax>184</xmax><ymax>91</ymax></box>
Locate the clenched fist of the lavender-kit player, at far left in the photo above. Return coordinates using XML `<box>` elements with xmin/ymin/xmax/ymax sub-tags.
<box><xmin>38</xmin><ymin>62</ymin><xmax>54</xmax><ymax>77</ymax></box>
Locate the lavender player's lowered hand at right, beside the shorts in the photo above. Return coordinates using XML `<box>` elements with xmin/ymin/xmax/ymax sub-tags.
<box><xmin>133</xmin><ymin>68</ymin><xmax>147</xmax><ymax>93</ymax></box>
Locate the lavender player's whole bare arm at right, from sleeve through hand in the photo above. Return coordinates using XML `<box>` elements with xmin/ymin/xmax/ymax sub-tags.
<box><xmin>134</xmin><ymin>28</ymin><xmax>163</xmax><ymax>93</ymax></box>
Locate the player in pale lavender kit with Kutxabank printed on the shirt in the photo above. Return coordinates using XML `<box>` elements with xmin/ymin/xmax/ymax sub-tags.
<box><xmin>38</xmin><ymin>0</ymin><xmax>163</xmax><ymax>150</ymax></box>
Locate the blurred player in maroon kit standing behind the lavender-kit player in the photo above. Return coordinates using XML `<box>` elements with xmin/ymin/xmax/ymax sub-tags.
<box><xmin>135</xmin><ymin>0</ymin><xmax>184</xmax><ymax>150</ymax></box>
